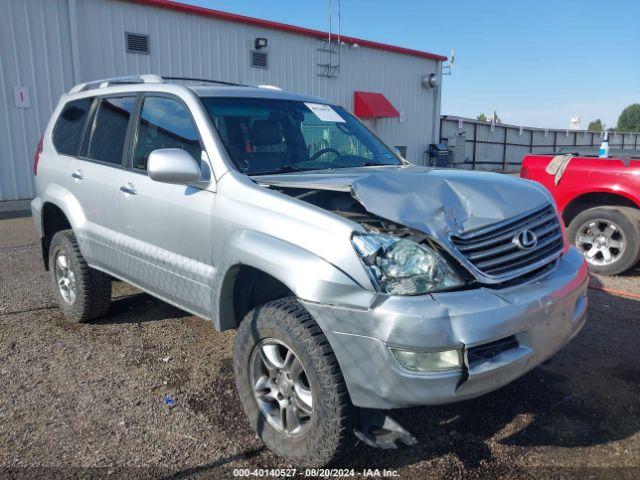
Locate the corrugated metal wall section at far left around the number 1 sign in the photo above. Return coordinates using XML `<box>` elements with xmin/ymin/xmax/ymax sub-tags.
<box><xmin>0</xmin><ymin>0</ymin><xmax>73</xmax><ymax>200</ymax></box>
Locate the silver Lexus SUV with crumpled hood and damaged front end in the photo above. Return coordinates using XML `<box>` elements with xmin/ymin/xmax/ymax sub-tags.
<box><xmin>32</xmin><ymin>75</ymin><xmax>587</xmax><ymax>465</ymax></box>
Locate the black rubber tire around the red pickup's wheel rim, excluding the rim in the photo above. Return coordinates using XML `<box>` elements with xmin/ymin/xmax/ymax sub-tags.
<box><xmin>567</xmin><ymin>207</ymin><xmax>640</xmax><ymax>275</ymax></box>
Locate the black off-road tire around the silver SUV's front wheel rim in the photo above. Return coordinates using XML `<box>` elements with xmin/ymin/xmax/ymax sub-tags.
<box><xmin>233</xmin><ymin>297</ymin><xmax>356</xmax><ymax>467</ymax></box>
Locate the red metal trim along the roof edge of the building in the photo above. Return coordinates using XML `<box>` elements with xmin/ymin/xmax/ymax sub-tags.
<box><xmin>131</xmin><ymin>0</ymin><xmax>447</xmax><ymax>62</ymax></box>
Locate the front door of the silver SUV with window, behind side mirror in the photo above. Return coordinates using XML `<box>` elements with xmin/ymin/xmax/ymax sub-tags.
<box><xmin>117</xmin><ymin>94</ymin><xmax>215</xmax><ymax>316</ymax></box>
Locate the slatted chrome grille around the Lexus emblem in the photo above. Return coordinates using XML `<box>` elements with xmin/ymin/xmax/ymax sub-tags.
<box><xmin>451</xmin><ymin>205</ymin><xmax>563</xmax><ymax>279</ymax></box>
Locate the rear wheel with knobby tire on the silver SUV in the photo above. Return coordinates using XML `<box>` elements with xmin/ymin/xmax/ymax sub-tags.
<box><xmin>49</xmin><ymin>230</ymin><xmax>111</xmax><ymax>323</ymax></box>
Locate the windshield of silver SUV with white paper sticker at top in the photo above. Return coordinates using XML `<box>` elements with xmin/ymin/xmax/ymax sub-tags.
<box><xmin>202</xmin><ymin>97</ymin><xmax>400</xmax><ymax>175</ymax></box>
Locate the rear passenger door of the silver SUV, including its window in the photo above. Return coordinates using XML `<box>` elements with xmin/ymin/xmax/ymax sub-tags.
<box><xmin>68</xmin><ymin>95</ymin><xmax>136</xmax><ymax>271</ymax></box>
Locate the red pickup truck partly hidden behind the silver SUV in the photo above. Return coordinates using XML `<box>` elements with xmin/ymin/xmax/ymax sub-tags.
<box><xmin>520</xmin><ymin>154</ymin><xmax>640</xmax><ymax>275</ymax></box>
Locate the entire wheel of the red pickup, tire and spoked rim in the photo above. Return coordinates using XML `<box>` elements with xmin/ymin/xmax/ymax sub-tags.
<box><xmin>567</xmin><ymin>207</ymin><xmax>640</xmax><ymax>275</ymax></box>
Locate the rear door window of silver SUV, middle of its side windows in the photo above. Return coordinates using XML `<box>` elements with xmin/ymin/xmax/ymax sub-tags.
<box><xmin>84</xmin><ymin>97</ymin><xmax>136</xmax><ymax>165</ymax></box>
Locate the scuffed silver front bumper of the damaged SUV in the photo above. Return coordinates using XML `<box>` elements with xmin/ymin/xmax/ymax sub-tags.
<box><xmin>305</xmin><ymin>248</ymin><xmax>588</xmax><ymax>409</ymax></box>
